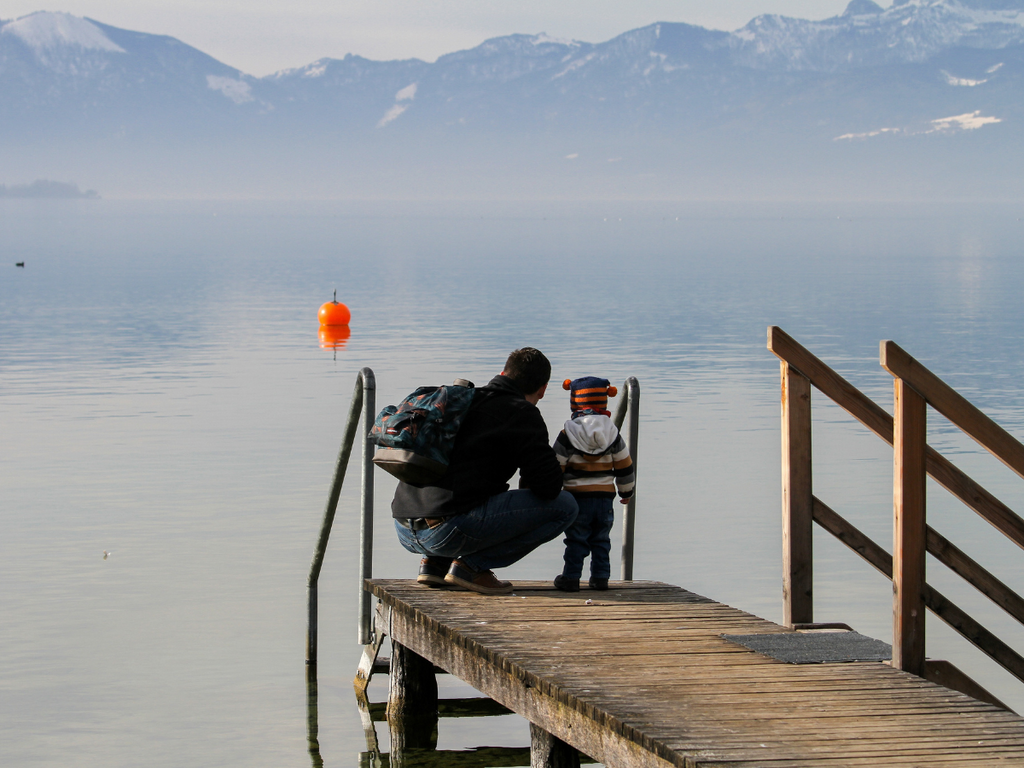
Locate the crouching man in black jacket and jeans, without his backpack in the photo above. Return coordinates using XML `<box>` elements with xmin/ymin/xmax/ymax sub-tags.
<box><xmin>391</xmin><ymin>347</ymin><xmax>578</xmax><ymax>595</ymax></box>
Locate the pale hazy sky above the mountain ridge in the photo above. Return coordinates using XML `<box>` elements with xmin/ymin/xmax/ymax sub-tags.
<box><xmin>6</xmin><ymin>0</ymin><xmax>880</xmax><ymax>76</ymax></box>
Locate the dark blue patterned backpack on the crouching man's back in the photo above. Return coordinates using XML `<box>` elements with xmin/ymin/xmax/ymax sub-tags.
<box><xmin>370</xmin><ymin>379</ymin><xmax>476</xmax><ymax>485</ymax></box>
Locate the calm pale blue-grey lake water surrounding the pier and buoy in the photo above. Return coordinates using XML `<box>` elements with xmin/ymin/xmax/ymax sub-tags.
<box><xmin>0</xmin><ymin>201</ymin><xmax>1024</xmax><ymax>768</ymax></box>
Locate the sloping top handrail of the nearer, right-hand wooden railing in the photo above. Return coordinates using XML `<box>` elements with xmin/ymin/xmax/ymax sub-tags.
<box><xmin>880</xmin><ymin>341</ymin><xmax>1024</xmax><ymax>477</ymax></box>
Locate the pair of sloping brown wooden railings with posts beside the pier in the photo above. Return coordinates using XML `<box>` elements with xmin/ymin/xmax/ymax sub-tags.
<box><xmin>768</xmin><ymin>326</ymin><xmax>1024</xmax><ymax>681</ymax></box>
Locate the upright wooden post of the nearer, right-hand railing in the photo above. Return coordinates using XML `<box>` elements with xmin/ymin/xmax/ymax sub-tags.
<box><xmin>883</xmin><ymin>374</ymin><xmax>928</xmax><ymax>677</ymax></box>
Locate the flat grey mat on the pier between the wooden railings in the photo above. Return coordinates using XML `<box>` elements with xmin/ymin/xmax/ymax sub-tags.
<box><xmin>722</xmin><ymin>632</ymin><xmax>892</xmax><ymax>664</ymax></box>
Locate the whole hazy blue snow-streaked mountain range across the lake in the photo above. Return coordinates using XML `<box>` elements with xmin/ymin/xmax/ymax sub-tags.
<box><xmin>0</xmin><ymin>0</ymin><xmax>1024</xmax><ymax>198</ymax></box>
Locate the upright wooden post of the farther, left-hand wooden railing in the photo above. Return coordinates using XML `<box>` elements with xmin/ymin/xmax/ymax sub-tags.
<box><xmin>779</xmin><ymin>360</ymin><xmax>814</xmax><ymax>627</ymax></box>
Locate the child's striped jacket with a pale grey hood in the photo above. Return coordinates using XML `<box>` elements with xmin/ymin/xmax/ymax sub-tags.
<box><xmin>554</xmin><ymin>411</ymin><xmax>635</xmax><ymax>499</ymax></box>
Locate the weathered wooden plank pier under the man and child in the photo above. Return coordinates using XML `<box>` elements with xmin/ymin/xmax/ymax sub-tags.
<box><xmin>360</xmin><ymin>580</ymin><xmax>1024</xmax><ymax>768</ymax></box>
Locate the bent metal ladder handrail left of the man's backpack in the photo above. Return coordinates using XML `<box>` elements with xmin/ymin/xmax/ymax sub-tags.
<box><xmin>306</xmin><ymin>368</ymin><xmax>377</xmax><ymax>665</ymax></box>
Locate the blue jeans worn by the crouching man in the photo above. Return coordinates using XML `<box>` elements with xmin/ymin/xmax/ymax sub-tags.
<box><xmin>394</xmin><ymin>490</ymin><xmax>577</xmax><ymax>570</ymax></box>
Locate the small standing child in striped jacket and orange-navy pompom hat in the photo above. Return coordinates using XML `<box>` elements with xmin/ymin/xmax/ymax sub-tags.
<box><xmin>554</xmin><ymin>376</ymin><xmax>634</xmax><ymax>592</ymax></box>
